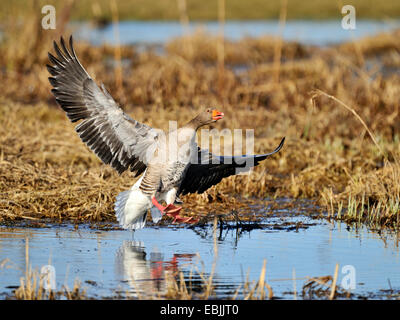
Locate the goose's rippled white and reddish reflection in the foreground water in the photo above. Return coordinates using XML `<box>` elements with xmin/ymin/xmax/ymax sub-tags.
<box><xmin>115</xmin><ymin>240</ymin><xmax>195</xmax><ymax>296</ymax></box>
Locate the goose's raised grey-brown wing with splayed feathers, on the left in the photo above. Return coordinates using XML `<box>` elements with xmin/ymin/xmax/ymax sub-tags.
<box><xmin>47</xmin><ymin>36</ymin><xmax>159</xmax><ymax>176</ymax></box>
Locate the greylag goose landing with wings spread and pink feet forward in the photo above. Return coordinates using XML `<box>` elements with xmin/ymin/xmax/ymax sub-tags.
<box><xmin>47</xmin><ymin>36</ymin><xmax>285</xmax><ymax>230</ymax></box>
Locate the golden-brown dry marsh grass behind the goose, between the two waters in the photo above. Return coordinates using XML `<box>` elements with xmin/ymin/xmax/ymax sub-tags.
<box><xmin>0</xmin><ymin>4</ymin><xmax>400</xmax><ymax>228</ymax></box>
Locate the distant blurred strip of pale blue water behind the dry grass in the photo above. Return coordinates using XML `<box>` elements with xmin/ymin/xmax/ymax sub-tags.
<box><xmin>72</xmin><ymin>19</ymin><xmax>400</xmax><ymax>46</ymax></box>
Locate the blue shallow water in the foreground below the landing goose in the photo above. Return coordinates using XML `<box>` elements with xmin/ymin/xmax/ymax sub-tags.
<box><xmin>0</xmin><ymin>211</ymin><xmax>400</xmax><ymax>299</ymax></box>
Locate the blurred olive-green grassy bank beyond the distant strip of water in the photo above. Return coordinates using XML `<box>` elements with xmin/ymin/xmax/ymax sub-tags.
<box><xmin>0</xmin><ymin>0</ymin><xmax>400</xmax><ymax>21</ymax></box>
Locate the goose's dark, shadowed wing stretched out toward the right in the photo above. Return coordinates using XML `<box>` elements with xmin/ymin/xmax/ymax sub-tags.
<box><xmin>178</xmin><ymin>138</ymin><xmax>285</xmax><ymax>195</ymax></box>
